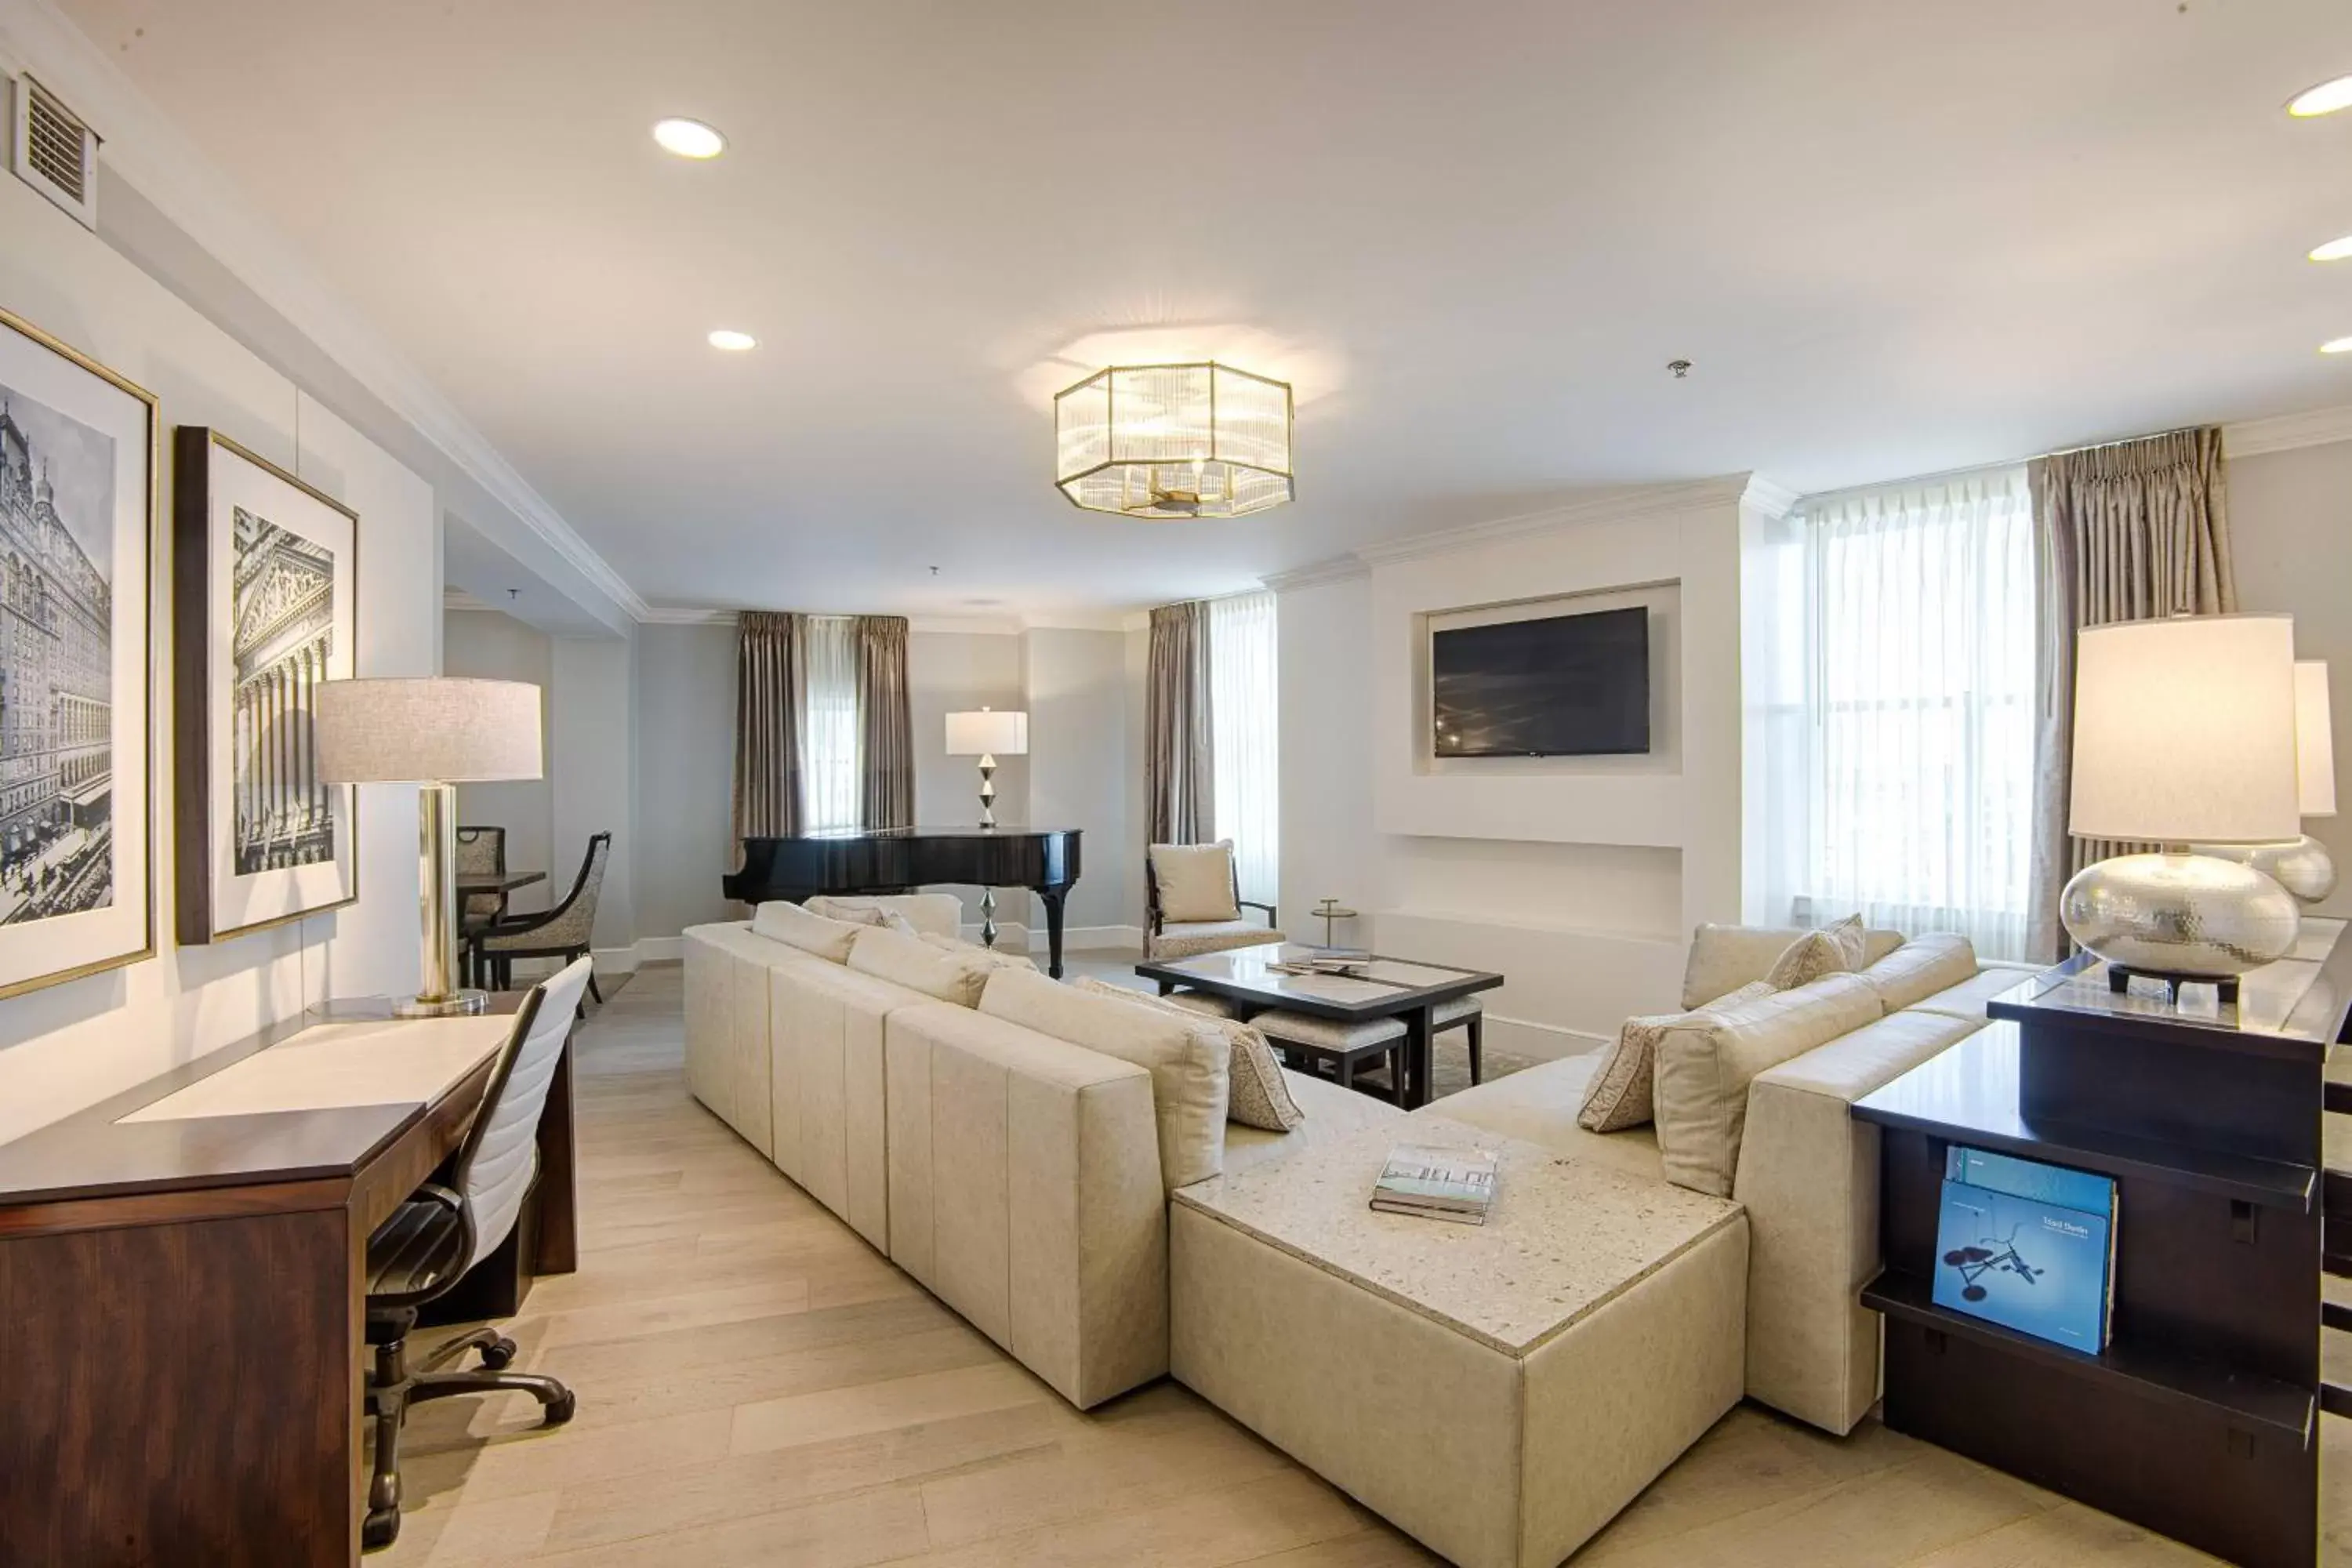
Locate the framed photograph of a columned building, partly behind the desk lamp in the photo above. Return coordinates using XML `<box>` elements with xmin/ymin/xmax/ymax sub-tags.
<box><xmin>172</xmin><ymin>426</ymin><xmax>360</xmax><ymax>945</ymax></box>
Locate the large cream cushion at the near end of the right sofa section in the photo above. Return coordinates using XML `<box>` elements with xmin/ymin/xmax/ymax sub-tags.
<box><xmin>1656</xmin><ymin>975</ymin><xmax>1886</xmax><ymax>1196</ymax></box>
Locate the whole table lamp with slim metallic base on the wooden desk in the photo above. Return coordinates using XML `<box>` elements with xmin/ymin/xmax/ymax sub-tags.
<box><xmin>315</xmin><ymin>675</ymin><xmax>541</xmax><ymax>1018</ymax></box>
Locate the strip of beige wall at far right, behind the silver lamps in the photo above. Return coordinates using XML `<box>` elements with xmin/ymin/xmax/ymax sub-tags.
<box><xmin>2230</xmin><ymin>442</ymin><xmax>2352</xmax><ymax>916</ymax></box>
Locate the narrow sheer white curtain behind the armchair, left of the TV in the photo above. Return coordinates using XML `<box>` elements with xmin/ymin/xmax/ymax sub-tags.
<box><xmin>1209</xmin><ymin>593</ymin><xmax>1282</xmax><ymax>902</ymax></box>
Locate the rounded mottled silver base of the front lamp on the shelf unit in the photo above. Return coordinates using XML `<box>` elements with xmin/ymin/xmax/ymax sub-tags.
<box><xmin>2058</xmin><ymin>848</ymin><xmax>2303</xmax><ymax>980</ymax></box>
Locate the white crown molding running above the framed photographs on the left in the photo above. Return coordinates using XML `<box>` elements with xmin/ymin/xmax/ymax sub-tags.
<box><xmin>0</xmin><ymin>0</ymin><xmax>649</xmax><ymax>621</ymax></box>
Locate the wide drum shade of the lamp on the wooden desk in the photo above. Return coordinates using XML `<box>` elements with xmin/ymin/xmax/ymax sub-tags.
<box><xmin>315</xmin><ymin>675</ymin><xmax>541</xmax><ymax>783</ymax></box>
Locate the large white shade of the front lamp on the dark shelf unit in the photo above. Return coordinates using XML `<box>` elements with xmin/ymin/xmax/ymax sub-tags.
<box><xmin>2067</xmin><ymin>616</ymin><xmax>2303</xmax><ymax>844</ymax></box>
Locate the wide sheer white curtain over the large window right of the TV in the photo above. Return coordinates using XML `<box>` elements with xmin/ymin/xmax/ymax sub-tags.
<box><xmin>1750</xmin><ymin>468</ymin><xmax>2034</xmax><ymax>959</ymax></box>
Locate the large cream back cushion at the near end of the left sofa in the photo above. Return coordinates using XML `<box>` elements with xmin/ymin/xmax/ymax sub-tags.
<box><xmin>981</xmin><ymin>968</ymin><xmax>1230</xmax><ymax>1192</ymax></box>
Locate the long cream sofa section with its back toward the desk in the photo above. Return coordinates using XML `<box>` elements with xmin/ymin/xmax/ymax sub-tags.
<box><xmin>684</xmin><ymin>895</ymin><xmax>1404</xmax><ymax>1408</ymax></box>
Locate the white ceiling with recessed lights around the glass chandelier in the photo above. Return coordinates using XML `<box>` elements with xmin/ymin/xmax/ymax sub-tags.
<box><xmin>50</xmin><ymin>0</ymin><xmax>2352</xmax><ymax>614</ymax></box>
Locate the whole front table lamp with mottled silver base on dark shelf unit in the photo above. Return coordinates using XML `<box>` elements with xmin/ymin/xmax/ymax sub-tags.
<box><xmin>2058</xmin><ymin>616</ymin><xmax>2298</xmax><ymax>1001</ymax></box>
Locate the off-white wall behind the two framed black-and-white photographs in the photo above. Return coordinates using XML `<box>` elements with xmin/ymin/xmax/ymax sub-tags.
<box><xmin>0</xmin><ymin>179</ymin><xmax>440</xmax><ymax>1142</ymax></box>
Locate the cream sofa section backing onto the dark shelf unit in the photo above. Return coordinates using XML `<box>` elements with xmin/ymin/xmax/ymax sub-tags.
<box><xmin>1416</xmin><ymin>926</ymin><xmax>2032</xmax><ymax>1434</ymax></box>
